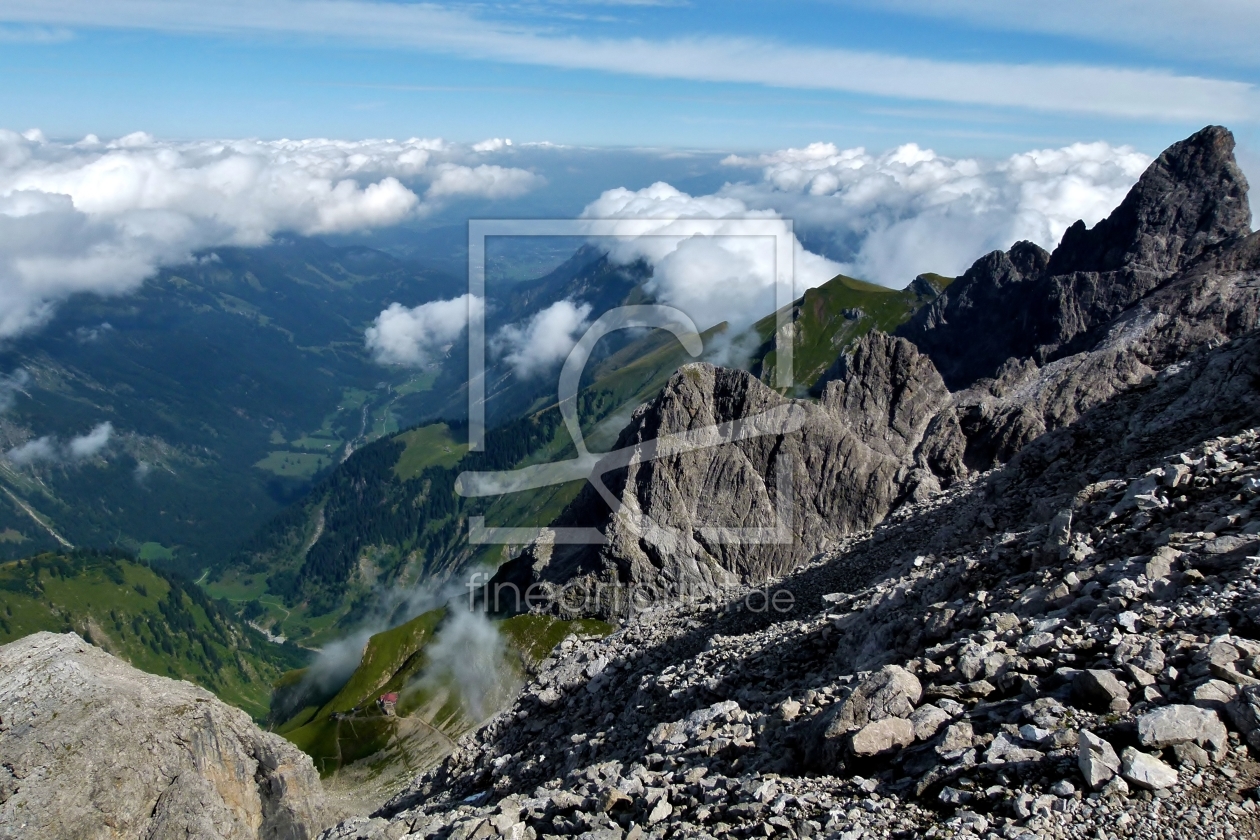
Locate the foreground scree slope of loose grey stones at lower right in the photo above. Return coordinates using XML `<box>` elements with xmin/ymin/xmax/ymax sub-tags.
<box><xmin>325</xmin><ymin>327</ymin><xmax>1260</xmax><ymax>839</ymax></box>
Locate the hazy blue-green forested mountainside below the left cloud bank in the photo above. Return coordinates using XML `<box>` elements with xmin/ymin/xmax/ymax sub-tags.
<box><xmin>0</xmin><ymin>238</ymin><xmax>464</xmax><ymax>577</ymax></box>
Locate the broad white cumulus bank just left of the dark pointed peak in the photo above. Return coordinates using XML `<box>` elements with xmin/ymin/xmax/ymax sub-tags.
<box><xmin>718</xmin><ymin>142</ymin><xmax>1150</xmax><ymax>287</ymax></box>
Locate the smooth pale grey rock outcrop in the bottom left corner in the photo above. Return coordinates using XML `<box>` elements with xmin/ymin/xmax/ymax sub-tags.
<box><xmin>0</xmin><ymin>632</ymin><xmax>333</xmax><ymax>840</ymax></box>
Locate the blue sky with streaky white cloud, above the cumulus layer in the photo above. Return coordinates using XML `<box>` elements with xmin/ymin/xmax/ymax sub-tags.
<box><xmin>0</xmin><ymin>0</ymin><xmax>1260</xmax><ymax>155</ymax></box>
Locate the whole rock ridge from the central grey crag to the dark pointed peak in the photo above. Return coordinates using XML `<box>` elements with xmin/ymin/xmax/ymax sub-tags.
<box><xmin>498</xmin><ymin>127</ymin><xmax>1260</xmax><ymax>612</ymax></box>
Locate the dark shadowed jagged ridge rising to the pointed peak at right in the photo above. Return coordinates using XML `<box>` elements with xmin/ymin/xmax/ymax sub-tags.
<box><xmin>898</xmin><ymin>126</ymin><xmax>1251</xmax><ymax>389</ymax></box>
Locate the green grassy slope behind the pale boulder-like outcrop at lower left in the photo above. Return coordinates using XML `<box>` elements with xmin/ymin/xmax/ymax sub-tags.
<box><xmin>0</xmin><ymin>552</ymin><xmax>307</xmax><ymax>719</ymax></box>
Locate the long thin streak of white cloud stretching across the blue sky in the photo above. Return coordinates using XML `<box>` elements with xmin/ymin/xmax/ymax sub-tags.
<box><xmin>0</xmin><ymin>0</ymin><xmax>1260</xmax><ymax>122</ymax></box>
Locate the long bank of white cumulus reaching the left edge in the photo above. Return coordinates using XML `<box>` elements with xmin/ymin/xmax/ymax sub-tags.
<box><xmin>0</xmin><ymin>131</ymin><xmax>541</xmax><ymax>339</ymax></box>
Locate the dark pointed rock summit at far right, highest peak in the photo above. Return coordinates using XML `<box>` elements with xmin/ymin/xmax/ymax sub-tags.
<box><xmin>1047</xmin><ymin>126</ymin><xmax>1251</xmax><ymax>275</ymax></box>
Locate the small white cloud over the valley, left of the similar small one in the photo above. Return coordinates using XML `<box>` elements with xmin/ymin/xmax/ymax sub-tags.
<box><xmin>365</xmin><ymin>295</ymin><xmax>485</xmax><ymax>368</ymax></box>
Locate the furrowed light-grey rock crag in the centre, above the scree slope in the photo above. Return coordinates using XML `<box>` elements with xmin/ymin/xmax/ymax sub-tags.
<box><xmin>499</xmin><ymin>332</ymin><xmax>949</xmax><ymax>612</ymax></box>
